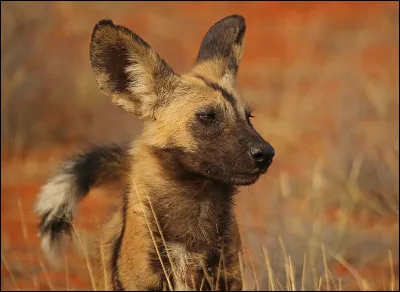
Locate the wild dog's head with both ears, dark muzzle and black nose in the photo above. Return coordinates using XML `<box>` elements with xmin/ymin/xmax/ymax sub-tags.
<box><xmin>90</xmin><ymin>15</ymin><xmax>274</xmax><ymax>185</ymax></box>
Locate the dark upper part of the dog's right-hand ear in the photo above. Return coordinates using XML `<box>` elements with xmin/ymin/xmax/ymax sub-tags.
<box><xmin>197</xmin><ymin>15</ymin><xmax>246</xmax><ymax>62</ymax></box>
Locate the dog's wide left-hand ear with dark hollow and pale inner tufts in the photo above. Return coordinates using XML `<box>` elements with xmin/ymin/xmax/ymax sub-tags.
<box><xmin>90</xmin><ymin>20</ymin><xmax>178</xmax><ymax>118</ymax></box>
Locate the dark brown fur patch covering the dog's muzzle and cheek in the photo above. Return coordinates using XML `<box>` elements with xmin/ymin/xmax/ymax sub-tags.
<box><xmin>150</xmin><ymin>121</ymin><xmax>264</xmax><ymax>187</ymax></box>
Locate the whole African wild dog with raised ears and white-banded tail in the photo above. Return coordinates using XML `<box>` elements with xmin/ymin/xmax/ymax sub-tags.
<box><xmin>36</xmin><ymin>15</ymin><xmax>274</xmax><ymax>290</ymax></box>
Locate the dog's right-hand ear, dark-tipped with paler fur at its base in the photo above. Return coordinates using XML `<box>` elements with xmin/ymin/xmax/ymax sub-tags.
<box><xmin>197</xmin><ymin>15</ymin><xmax>246</xmax><ymax>86</ymax></box>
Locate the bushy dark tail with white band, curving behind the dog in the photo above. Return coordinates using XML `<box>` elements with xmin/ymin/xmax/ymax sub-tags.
<box><xmin>35</xmin><ymin>146</ymin><xmax>129</xmax><ymax>264</ymax></box>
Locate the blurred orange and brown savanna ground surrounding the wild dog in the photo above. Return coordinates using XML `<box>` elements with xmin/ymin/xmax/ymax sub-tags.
<box><xmin>1</xmin><ymin>1</ymin><xmax>399</xmax><ymax>290</ymax></box>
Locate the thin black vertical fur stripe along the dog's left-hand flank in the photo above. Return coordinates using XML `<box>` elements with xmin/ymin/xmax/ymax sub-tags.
<box><xmin>111</xmin><ymin>189</ymin><xmax>128</xmax><ymax>291</ymax></box>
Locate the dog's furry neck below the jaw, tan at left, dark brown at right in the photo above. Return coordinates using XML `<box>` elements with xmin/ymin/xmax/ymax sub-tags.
<box><xmin>131</xmin><ymin>146</ymin><xmax>236</xmax><ymax>250</ymax></box>
